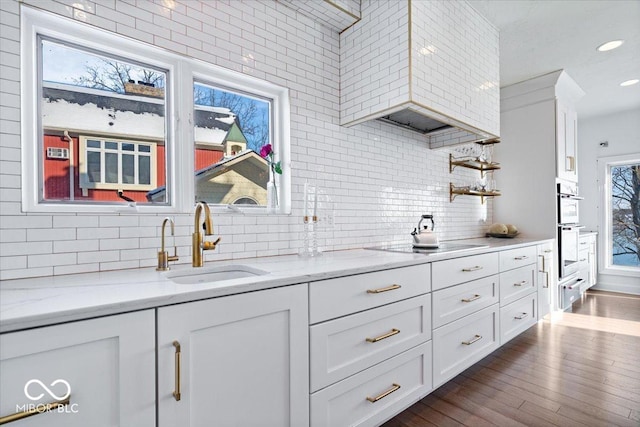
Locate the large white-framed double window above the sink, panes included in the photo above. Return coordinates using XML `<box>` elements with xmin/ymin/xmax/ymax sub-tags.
<box><xmin>21</xmin><ymin>5</ymin><xmax>291</xmax><ymax>213</ymax></box>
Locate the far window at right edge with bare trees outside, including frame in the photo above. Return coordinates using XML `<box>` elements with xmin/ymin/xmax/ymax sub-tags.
<box><xmin>599</xmin><ymin>155</ymin><xmax>640</xmax><ymax>274</ymax></box>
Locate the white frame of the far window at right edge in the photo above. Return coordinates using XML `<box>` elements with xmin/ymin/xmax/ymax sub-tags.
<box><xmin>598</xmin><ymin>153</ymin><xmax>640</xmax><ymax>276</ymax></box>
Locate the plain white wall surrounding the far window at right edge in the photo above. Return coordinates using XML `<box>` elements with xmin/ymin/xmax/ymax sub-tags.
<box><xmin>578</xmin><ymin>107</ymin><xmax>640</xmax><ymax>294</ymax></box>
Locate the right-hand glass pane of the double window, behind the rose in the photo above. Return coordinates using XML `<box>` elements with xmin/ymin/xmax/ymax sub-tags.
<box><xmin>193</xmin><ymin>82</ymin><xmax>276</xmax><ymax>206</ymax></box>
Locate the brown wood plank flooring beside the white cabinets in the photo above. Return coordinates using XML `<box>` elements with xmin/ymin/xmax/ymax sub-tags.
<box><xmin>383</xmin><ymin>291</ymin><xmax>640</xmax><ymax>427</ymax></box>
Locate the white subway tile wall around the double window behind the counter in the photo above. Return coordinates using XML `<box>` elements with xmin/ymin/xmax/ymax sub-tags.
<box><xmin>0</xmin><ymin>0</ymin><xmax>492</xmax><ymax>279</ymax></box>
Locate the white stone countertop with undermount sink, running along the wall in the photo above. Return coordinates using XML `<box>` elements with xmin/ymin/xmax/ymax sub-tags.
<box><xmin>0</xmin><ymin>237</ymin><xmax>549</xmax><ymax>333</ymax></box>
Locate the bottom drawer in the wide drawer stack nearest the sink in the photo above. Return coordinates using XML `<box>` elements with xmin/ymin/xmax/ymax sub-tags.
<box><xmin>311</xmin><ymin>341</ymin><xmax>432</xmax><ymax>427</ymax></box>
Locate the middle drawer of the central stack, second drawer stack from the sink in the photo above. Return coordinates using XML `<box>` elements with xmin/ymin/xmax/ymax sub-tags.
<box><xmin>433</xmin><ymin>274</ymin><xmax>499</xmax><ymax>328</ymax></box>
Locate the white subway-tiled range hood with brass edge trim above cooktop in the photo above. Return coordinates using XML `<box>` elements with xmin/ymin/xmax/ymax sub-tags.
<box><xmin>340</xmin><ymin>0</ymin><xmax>500</xmax><ymax>148</ymax></box>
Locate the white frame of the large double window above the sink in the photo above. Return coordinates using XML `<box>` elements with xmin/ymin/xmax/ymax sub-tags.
<box><xmin>20</xmin><ymin>5</ymin><xmax>291</xmax><ymax>214</ymax></box>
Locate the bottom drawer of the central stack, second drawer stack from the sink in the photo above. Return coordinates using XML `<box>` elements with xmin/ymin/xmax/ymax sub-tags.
<box><xmin>433</xmin><ymin>304</ymin><xmax>500</xmax><ymax>388</ymax></box>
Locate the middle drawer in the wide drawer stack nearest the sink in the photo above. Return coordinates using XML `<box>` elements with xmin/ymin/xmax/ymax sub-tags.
<box><xmin>309</xmin><ymin>294</ymin><xmax>431</xmax><ymax>392</ymax></box>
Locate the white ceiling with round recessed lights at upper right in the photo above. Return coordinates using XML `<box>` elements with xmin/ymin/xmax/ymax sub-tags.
<box><xmin>469</xmin><ymin>0</ymin><xmax>640</xmax><ymax>118</ymax></box>
